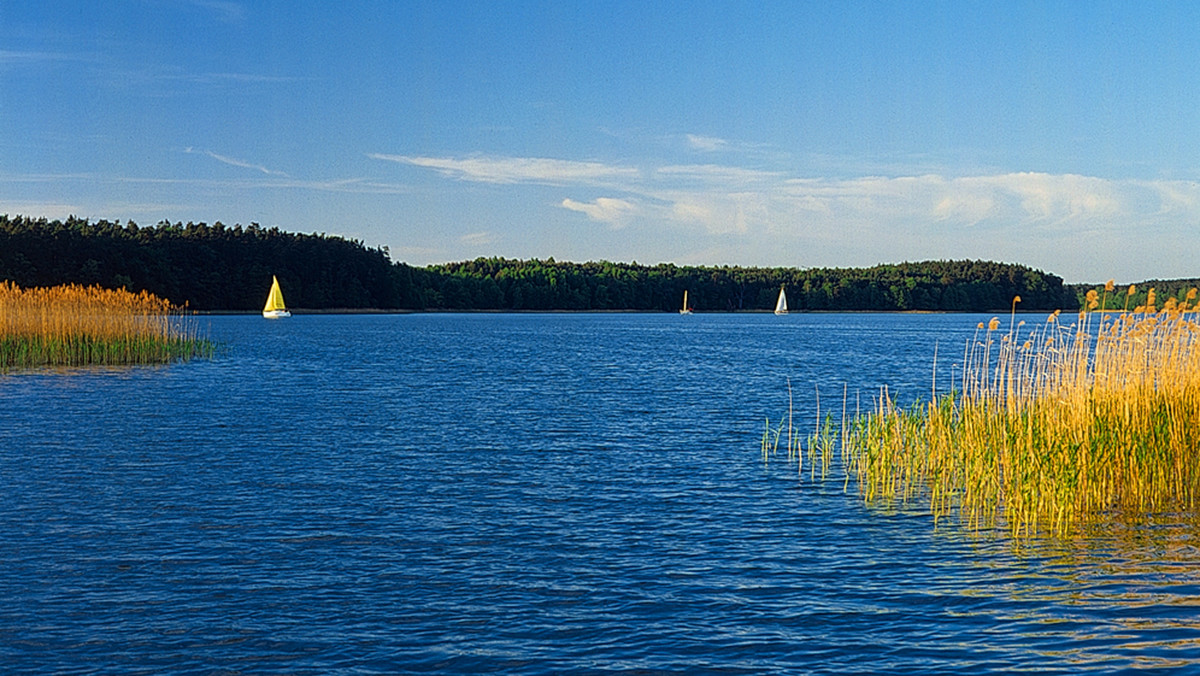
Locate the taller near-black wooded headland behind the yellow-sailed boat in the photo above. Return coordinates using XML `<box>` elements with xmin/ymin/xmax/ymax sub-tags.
<box><xmin>0</xmin><ymin>216</ymin><xmax>403</xmax><ymax>311</ymax></box>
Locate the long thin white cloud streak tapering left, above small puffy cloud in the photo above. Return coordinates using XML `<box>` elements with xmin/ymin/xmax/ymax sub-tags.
<box><xmin>368</xmin><ymin>152</ymin><xmax>640</xmax><ymax>185</ymax></box>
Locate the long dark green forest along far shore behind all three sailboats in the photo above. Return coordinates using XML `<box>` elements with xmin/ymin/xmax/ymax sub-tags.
<box><xmin>0</xmin><ymin>215</ymin><xmax>1089</xmax><ymax>312</ymax></box>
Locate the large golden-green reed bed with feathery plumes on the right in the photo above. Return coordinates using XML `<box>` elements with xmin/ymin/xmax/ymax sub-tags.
<box><xmin>762</xmin><ymin>282</ymin><xmax>1200</xmax><ymax>538</ymax></box>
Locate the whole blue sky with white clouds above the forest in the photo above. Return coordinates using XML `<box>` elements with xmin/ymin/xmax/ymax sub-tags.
<box><xmin>0</xmin><ymin>0</ymin><xmax>1200</xmax><ymax>282</ymax></box>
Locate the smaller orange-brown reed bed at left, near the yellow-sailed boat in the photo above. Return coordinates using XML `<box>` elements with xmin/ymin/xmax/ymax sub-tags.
<box><xmin>0</xmin><ymin>282</ymin><xmax>214</xmax><ymax>371</ymax></box>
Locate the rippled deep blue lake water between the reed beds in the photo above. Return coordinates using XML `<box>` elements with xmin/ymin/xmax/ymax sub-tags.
<box><xmin>0</xmin><ymin>315</ymin><xmax>1200</xmax><ymax>674</ymax></box>
